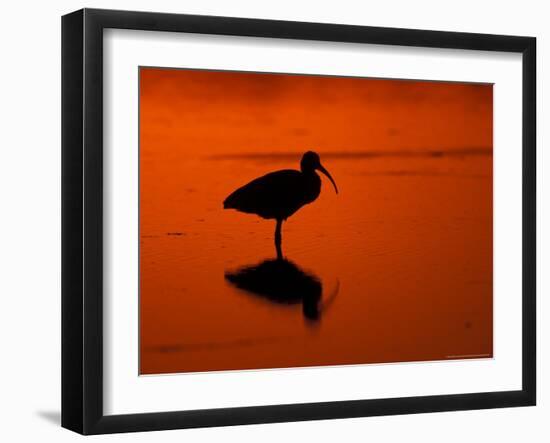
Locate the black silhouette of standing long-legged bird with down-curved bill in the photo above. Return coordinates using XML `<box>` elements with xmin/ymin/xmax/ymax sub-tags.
<box><xmin>223</xmin><ymin>151</ymin><xmax>338</xmax><ymax>259</ymax></box>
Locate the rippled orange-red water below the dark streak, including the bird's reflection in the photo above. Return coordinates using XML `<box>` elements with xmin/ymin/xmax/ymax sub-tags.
<box><xmin>140</xmin><ymin>153</ymin><xmax>492</xmax><ymax>374</ymax></box>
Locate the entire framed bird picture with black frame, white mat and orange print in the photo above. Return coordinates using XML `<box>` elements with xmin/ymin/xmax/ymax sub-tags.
<box><xmin>62</xmin><ymin>9</ymin><xmax>536</xmax><ymax>434</ymax></box>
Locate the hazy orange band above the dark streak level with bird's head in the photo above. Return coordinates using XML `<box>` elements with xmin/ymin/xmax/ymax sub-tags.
<box><xmin>140</xmin><ymin>68</ymin><xmax>492</xmax><ymax>159</ymax></box>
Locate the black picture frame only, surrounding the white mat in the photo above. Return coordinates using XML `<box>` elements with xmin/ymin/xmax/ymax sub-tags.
<box><xmin>62</xmin><ymin>9</ymin><xmax>536</xmax><ymax>434</ymax></box>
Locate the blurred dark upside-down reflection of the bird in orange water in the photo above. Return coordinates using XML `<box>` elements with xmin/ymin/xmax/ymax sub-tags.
<box><xmin>225</xmin><ymin>259</ymin><xmax>338</xmax><ymax>323</ymax></box>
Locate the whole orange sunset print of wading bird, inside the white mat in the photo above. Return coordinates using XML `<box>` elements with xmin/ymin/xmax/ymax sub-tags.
<box><xmin>139</xmin><ymin>67</ymin><xmax>493</xmax><ymax>375</ymax></box>
